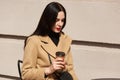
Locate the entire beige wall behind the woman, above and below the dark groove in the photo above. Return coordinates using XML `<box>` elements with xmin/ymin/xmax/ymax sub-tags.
<box><xmin>0</xmin><ymin>0</ymin><xmax>120</xmax><ymax>80</ymax></box>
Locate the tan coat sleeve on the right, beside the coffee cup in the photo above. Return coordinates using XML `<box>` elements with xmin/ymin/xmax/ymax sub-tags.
<box><xmin>66</xmin><ymin>49</ymin><xmax>78</xmax><ymax>80</ymax></box>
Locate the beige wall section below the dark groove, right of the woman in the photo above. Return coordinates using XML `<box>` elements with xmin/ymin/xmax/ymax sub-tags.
<box><xmin>72</xmin><ymin>45</ymin><xmax>120</xmax><ymax>80</ymax></box>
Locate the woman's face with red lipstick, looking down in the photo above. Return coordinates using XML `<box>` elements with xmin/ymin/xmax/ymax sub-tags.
<box><xmin>52</xmin><ymin>11</ymin><xmax>65</xmax><ymax>33</ymax></box>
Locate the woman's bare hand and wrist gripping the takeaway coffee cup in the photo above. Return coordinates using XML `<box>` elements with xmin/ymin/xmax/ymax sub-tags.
<box><xmin>45</xmin><ymin>57</ymin><xmax>66</xmax><ymax>75</ymax></box>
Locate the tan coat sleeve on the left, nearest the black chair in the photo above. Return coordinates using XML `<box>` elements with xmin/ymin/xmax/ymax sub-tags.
<box><xmin>22</xmin><ymin>38</ymin><xmax>45</xmax><ymax>80</ymax></box>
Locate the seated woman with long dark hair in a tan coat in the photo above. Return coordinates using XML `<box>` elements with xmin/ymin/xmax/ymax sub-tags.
<box><xmin>22</xmin><ymin>2</ymin><xmax>77</xmax><ymax>80</ymax></box>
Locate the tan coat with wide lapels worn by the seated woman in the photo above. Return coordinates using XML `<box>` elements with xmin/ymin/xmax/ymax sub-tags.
<box><xmin>22</xmin><ymin>34</ymin><xmax>78</xmax><ymax>80</ymax></box>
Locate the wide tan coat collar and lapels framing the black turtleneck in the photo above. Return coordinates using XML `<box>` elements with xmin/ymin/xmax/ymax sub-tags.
<box><xmin>40</xmin><ymin>34</ymin><xmax>71</xmax><ymax>57</ymax></box>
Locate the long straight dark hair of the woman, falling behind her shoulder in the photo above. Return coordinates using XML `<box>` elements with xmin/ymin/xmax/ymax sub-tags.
<box><xmin>24</xmin><ymin>2</ymin><xmax>66</xmax><ymax>47</ymax></box>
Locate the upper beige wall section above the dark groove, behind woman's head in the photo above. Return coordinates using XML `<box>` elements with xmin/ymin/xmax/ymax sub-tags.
<box><xmin>0</xmin><ymin>0</ymin><xmax>120</xmax><ymax>43</ymax></box>
